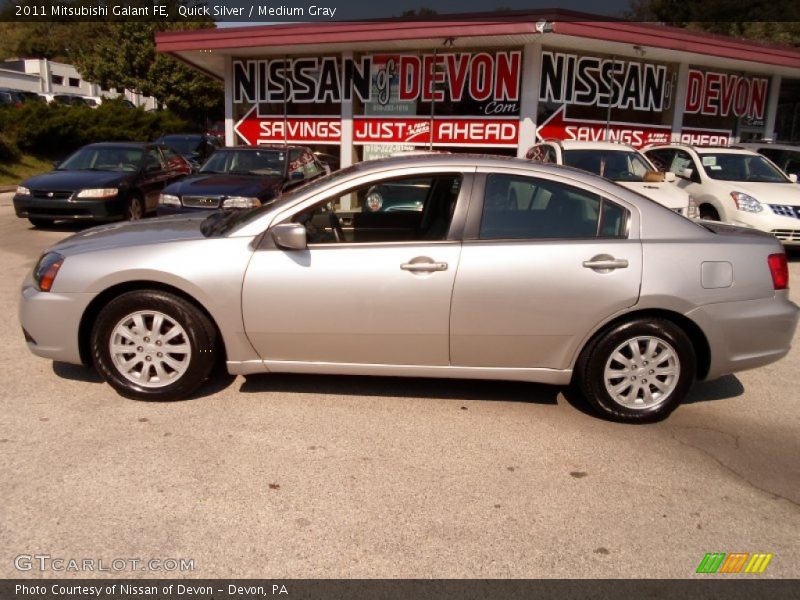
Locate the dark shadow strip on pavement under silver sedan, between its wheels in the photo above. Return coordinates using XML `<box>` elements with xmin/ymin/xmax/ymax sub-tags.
<box><xmin>239</xmin><ymin>373</ymin><xmax>561</xmax><ymax>405</ymax></box>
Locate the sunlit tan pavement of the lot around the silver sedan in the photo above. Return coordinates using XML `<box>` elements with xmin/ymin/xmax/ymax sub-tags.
<box><xmin>0</xmin><ymin>196</ymin><xmax>800</xmax><ymax>578</ymax></box>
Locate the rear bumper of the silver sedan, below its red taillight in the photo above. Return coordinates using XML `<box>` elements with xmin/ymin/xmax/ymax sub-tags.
<box><xmin>686</xmin><ymin>291</ymin><xmax>800</xmax><ymax>379</ymax></box>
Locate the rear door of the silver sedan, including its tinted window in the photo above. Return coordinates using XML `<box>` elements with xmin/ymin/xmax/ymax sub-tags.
<box><xmin>450</xmin><ymin>171</ymin><xmax>642</xmax><ymax>370</ymax></box>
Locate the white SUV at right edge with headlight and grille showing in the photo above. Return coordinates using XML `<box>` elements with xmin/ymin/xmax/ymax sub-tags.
<box><xmin>645</xmin><ymin>144</ymin><xmax>800</xmax><ymax>246</ymax></box>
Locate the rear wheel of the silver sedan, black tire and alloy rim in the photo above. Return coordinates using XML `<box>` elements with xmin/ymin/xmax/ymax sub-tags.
<box><xmin>576</xmin><ymin>318</ymin><xmax>697</xmax><ymax>423</ymax></box>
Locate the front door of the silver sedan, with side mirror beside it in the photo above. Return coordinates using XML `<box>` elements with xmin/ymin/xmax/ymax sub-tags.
<box><xmin>242</xmin><ymin>171</ymin><xmax>472</xmax><ymax>370</ymax></box>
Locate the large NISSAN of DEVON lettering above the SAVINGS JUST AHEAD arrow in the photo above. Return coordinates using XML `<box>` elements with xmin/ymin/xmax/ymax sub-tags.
<box><xmin>233</xmin><ymin>51</ymin><xmax>521</xmax><ymax>104</ymax></box>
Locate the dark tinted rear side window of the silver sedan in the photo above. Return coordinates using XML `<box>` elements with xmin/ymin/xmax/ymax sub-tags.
<box><xmin>480</xmin><ymin>174</ymin><xmax>628</xmax><ymax>240</ymax></box>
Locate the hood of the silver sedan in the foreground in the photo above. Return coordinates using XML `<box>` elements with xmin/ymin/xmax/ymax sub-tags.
<box><xmin>48</xmin><ymin>215</ymin><xmax>205</xmax><ymax>256</ymax></box>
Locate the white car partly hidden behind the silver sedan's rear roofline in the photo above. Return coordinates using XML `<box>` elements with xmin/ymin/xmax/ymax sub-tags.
<box><xmin>526</xmin><ymin>140</ymin><xmax>699</xmax><ymax>219</ymax></box>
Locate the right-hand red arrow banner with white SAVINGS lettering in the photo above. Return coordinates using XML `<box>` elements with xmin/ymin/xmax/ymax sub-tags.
<box><xmin>536</xmin><ymin>105</ymin><xmax>731</xmax><ymax>148</ymax></box>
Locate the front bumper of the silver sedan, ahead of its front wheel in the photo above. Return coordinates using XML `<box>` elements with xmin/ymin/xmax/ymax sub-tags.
<box><xmin>19</xmin><ymin>277</ymin><xmax>96</xmax><ymax>364</ymax></box>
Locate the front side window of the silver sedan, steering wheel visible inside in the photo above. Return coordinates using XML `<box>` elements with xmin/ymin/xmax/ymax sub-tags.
<box><xmin>292</xmin><ymin>174</ymin><xmax>461</xmax><ymax>244</ymax></box>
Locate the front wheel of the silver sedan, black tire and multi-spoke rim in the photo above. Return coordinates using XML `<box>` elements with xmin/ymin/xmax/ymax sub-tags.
<box><xmin>91</xmin><ymin>290</ymin><xmax>217</xmax><ymax>400</ymax></box>
